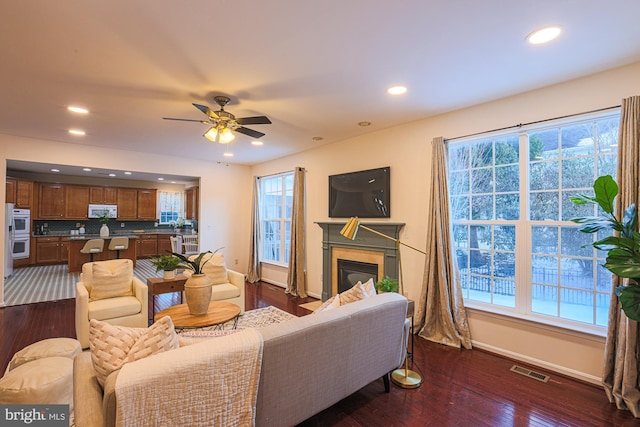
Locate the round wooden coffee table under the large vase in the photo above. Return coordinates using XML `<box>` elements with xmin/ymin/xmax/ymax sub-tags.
<box><xmin>153</xmin><ymin>301</ymin><xmax>240</xmax><ymax>329</ymax></box>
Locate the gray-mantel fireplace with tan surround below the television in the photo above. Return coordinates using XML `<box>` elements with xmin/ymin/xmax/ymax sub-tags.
<box><xmin>316</xmin><ymin>222</ymin><xmax>404</xmax><ymax>301</ymax></box>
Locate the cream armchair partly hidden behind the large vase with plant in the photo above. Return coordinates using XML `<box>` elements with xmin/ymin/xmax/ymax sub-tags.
<box><xmin>183</xmin><ymin>252</ymin><xmax>244</xmax><ymax>313</ymax></box>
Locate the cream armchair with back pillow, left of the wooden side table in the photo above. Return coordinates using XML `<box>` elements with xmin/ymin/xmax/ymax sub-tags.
<box><xmin>76</xmin><ymin>259</ymin><xmax>149</xmax><ymax>348</ymax></box>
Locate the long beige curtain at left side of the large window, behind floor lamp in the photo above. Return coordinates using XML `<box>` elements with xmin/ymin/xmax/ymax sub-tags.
<box><xmin>416</xmin><ymin>137</ymin><xmax>471</xmax><ymax>349</ymax></box>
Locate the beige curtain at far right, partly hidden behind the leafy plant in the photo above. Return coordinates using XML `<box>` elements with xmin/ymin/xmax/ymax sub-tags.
<box><xmin>602</xmin><ymin>96</ymin><xmax>640</xmax><ymax>417</ymax></box>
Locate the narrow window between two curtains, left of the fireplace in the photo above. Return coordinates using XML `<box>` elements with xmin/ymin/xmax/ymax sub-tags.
<box><xmin>260</xmin><ymin>172</ymin><xmax>293</xmax><ymax>265</ymax></box>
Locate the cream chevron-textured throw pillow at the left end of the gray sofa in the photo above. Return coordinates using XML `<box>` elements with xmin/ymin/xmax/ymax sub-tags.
<box><xmin>89</xmin><ymin>316</ymin><xmax>179</xmax><ymax>386</ymax></box>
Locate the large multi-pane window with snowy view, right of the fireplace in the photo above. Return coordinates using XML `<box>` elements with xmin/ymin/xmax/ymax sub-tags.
<box><xmin>449</xmin><ymin>114</ymin><xmax>619</xmax><ymax>331</ymax></box>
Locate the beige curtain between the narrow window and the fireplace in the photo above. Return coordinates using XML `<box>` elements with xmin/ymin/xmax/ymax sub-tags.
<box><xmin>285</xmin><ymin>168</ymin><xmax>307</xmax><ymax>298</ymax></box>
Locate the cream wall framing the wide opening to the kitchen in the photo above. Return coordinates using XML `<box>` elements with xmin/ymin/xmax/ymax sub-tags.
<box><xmin>0</xmin><ymin>134</ymin><xmax>252</xmax><ymax>303</ymax></box>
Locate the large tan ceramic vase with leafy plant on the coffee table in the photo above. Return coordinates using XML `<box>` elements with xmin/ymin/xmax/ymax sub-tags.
<box><xmin>172</xmin><ymin>250</ymin><xmax>217</xmax><ymax>316</ymax></box>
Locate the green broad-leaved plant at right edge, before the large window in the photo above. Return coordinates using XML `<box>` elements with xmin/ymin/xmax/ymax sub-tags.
<box><xmin>570</xmin><ymin>175</ymin><xmax>640</xmax><ymax>321</ymax></box>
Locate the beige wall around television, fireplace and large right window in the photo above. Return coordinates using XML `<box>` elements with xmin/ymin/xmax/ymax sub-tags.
<box><xmin>252</xmin><ymin>63</ymin><xmax>640</xmax><ymax>383</ymax></box>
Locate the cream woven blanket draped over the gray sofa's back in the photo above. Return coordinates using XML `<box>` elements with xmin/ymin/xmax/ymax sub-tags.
<box><xmin>115</xmin><ymin>329</ymin><xmax>263</xmax><ymax>427</ymax></box>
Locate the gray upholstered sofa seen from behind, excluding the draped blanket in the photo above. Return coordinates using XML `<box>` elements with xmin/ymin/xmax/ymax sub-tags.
<box><xmin>73</xmin><ymin>293</ymin><xmax>409</xmax><ymax>427</ymax></box>
